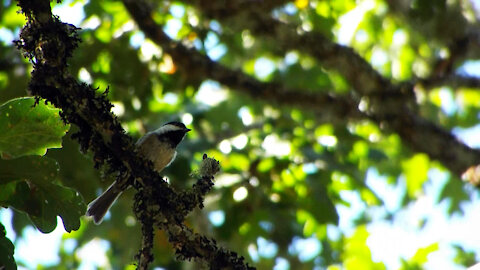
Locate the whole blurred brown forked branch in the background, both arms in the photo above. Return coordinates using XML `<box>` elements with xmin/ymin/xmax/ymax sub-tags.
<box><xmin>123</xmin><ymin>0</ymin><xmax>480</xmax><ymax>176</ymax></box>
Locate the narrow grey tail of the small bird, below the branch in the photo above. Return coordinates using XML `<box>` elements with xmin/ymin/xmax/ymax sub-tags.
<box><xmin>86</xmin><ymin>181</ymin><xmax>122</xmax><ymax>224</ymax></box>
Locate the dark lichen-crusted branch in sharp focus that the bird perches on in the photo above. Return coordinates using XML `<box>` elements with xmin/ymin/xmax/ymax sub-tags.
<box><xmin>16</xmin><ymin>0</ymin><xmax>248</xmax><ymax>269</ymax></box>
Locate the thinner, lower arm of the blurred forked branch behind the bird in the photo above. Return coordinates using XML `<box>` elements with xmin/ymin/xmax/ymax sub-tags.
<box><xmin>123</xmin><ymin>0</ymin><xmax>362</xmax><ymax>121</ymax></box>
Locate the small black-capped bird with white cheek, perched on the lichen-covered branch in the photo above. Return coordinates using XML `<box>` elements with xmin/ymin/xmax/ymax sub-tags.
<box><xmin>86</xmin><ymin>122</ymin><xmax>190</xmax><ymax>224</ymax></box>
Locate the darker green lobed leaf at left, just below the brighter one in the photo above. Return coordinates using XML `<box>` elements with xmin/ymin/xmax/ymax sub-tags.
<box><xmin>0</xmin><ymin>156</ymin><xmax>86</xmax><ymax>233</ymax></box>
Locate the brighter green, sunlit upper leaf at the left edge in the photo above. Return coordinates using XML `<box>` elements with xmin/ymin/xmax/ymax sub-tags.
<box><xmin>0</xmin><ymin>97</ymin><xmax>69</xmax><ymax>158</ymax></box>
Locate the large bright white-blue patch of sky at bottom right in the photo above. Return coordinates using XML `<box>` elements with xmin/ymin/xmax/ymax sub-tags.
<box><xmin>367</xmin><ymin>169</ymin><xmax>470</xmax><ymax>269</ymax></box>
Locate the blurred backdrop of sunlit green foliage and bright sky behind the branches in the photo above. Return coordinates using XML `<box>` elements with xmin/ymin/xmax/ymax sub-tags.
<box><xmin>0</xmin><ymin>0</ymin><xmax>480</xmax><ymax>270</ymax></box>
